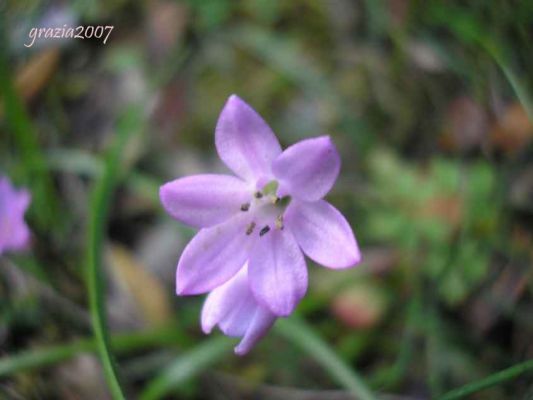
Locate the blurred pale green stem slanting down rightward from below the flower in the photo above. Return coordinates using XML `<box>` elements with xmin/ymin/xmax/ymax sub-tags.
<box><xmin>275</xmin><ymin>316</ymin><xmax>376</xmax><ymax>400</ymax></box>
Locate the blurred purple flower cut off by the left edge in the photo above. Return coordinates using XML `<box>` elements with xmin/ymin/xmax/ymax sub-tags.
<box><xmin>0</xmin><ymin>176</ymin><xmax>31</xmax><ymax>254</ymax></box>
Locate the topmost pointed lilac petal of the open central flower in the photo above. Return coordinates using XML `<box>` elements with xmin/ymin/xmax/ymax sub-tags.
<box><xmin>215</xmin><ymin>95</ymin><xmax>281</xmax><ymax>182</ymax></box>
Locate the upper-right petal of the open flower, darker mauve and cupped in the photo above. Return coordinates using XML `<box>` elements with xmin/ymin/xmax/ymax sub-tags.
<box><xmin>272</xmin><ymin>136</ymin><xmax>340</xmax><ymax>201</ymax></box>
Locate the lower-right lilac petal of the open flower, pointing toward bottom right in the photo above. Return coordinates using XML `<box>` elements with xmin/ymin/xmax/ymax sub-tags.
<box><xmin>284</xmin><ymin>200</ymin><xmax>361</xmax><ymax>268</ymax></box>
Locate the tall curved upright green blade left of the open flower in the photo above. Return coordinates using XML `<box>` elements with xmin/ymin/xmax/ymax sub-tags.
<box><xmin>87</xmin><ymin>109</ymin><xmax>138</xmax><ymax>400</ymax></box>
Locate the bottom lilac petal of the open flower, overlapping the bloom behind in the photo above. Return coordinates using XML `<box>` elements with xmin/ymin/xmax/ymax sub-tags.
<box><xmin>248</xmin><ymin>229</ymin><xmax>307</xmax><ymax>316</ymax></box>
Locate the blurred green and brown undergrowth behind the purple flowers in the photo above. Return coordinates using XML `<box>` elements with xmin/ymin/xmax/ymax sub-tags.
<box><xmin>0</xmin><ymin>0</ymin><xmax>533</xmax><ymax>400</ymax></box>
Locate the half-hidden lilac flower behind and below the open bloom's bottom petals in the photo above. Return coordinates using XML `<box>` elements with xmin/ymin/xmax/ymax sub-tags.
<box><xmin>202</xmin><ymin>266</ymin><xmax>276</xmax><ymax>355</ymax></box>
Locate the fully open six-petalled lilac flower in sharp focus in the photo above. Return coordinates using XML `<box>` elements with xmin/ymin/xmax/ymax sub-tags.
<box><xmin>160</xmin><ymin>95</ymin><xmax>361</xmax><ymax>318</ymax></box>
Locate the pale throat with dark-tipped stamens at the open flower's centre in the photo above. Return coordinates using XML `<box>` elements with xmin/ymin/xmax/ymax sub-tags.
<box><xmin>241</xmin><ymin>180</ymin><xmax>291</xmax><ymax>237</ymax></box>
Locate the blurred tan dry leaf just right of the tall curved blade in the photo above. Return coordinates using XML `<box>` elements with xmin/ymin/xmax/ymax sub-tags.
<box><xmin>107</xmin><ymin>245</ymin><xmax>172</xmax><ymax>325</ymax></box>
